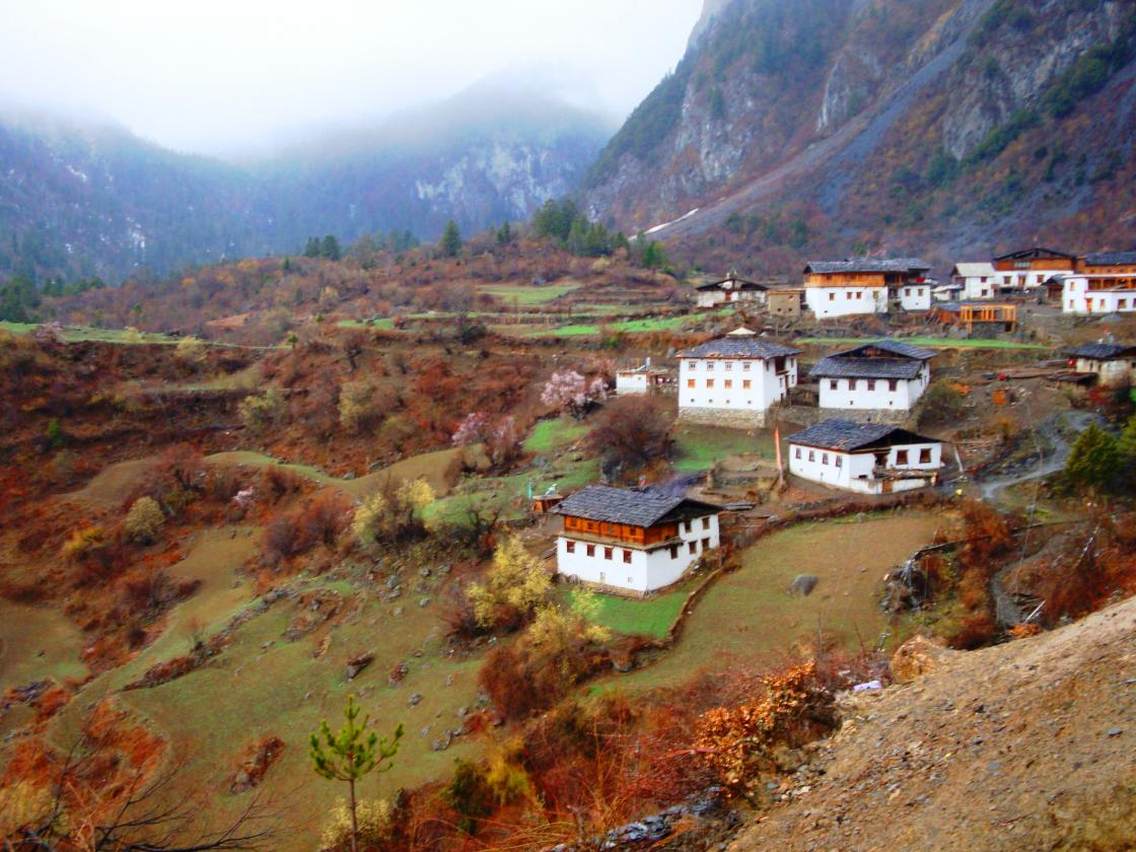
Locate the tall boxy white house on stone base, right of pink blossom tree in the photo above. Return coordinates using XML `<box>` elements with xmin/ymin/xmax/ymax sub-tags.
<box><xmin>678</xmin><ymin>328</ymin><xmax>801</xmax><ymax>427</ymax></box>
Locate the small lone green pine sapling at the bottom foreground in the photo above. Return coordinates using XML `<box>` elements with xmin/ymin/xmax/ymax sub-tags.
<box><xmin>309</xmin><ymin>695</ymin><xmax>402</xmax><ymax>852</ymax></box>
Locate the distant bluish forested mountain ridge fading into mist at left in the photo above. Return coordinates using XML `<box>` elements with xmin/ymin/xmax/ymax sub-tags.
<box><xmin>0</xmin><ymin>86</ymin><xmax>611</xmax><ymax>281</ymax></box>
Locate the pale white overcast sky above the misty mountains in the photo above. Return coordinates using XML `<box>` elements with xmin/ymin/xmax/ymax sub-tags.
<box><xmin>0</xmin><ymin>0</ymin><xmax>702</xmax><ymax>154</ymax></box>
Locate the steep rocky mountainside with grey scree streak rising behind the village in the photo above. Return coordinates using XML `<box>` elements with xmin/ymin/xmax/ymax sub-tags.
<box><xmin>583</xmin><ymin>0</ymin><xmax>1136</xmax><ymax>272</ymax></box>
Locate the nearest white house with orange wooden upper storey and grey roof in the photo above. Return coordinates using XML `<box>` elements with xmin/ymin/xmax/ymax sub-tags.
<box><xmin>554</xmin><ymin>485</ymin><xmax>720</xmax><ymax>594</ymax></box>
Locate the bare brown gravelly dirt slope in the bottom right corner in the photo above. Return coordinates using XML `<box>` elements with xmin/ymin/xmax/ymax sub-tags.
<box><xmin>733</xmin><ymin>599</ymin><xmax>1136</xmax><ymax>850</ymax></box>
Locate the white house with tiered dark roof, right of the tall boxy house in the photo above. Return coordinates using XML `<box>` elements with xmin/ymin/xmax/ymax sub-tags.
<box><xmin>809</xmin><ymin>340</ymin><xmax>935</xmax><ymax>411</ymax></box>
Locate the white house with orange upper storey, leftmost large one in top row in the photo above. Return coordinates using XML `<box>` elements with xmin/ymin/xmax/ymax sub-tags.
<box><xmin>804</xmin><ymin>258</ymin><xmax>934</xmax><ymax>319</ymax></box>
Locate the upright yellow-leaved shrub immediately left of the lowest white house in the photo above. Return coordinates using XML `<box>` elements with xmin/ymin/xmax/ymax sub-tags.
<box><xmin>467</xmin><ymin>536</ymin><xmax>552</xmax><ymax>629</ymax></box>
